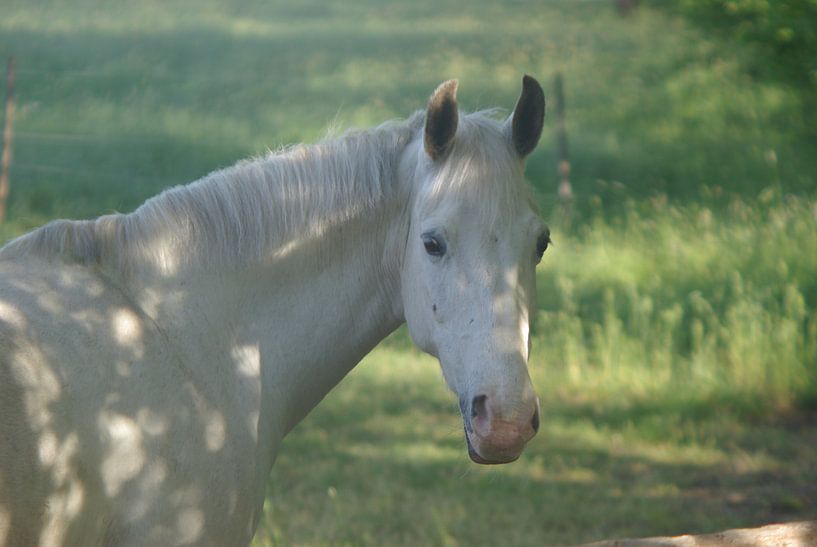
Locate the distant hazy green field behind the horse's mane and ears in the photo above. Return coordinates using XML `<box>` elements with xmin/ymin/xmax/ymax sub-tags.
<box><xmin>0</xmin><ymin>0</ymin><xmax>817</xmax><ymax>225</ymax></box>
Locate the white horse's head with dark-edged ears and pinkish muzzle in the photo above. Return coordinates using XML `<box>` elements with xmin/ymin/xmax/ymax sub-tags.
<box><xmin>401</xmin><ymin>76</ymin><xmax>550</xmax><ymax>463</ymax></box>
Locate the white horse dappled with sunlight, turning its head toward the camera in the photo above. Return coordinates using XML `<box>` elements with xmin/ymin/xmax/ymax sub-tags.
<box><xmin>0</xmin><ymin>76</ymin><xmax>549</xmax><ymax>546</ymax></box>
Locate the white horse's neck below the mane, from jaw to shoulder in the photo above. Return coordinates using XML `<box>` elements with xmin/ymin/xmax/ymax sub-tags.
<box><xmin>123</xmin><ymin>133</ymin><xmax>418</xmax><ymax>442</ymax></box>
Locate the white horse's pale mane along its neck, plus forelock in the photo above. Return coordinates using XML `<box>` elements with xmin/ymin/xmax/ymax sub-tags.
<box><xmin>0</xmin><ymin>111</ymin><xmax>524</xmax><ymax>271</ymax></box>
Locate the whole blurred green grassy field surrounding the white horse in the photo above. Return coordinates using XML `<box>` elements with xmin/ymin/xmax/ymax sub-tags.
<box><xmin>0</xmin><ymin>0</ymin><xmax>817</xmax><ymax>546</ymax></box>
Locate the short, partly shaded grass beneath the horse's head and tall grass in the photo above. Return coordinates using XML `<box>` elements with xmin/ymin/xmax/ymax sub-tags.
<box><xmin>256</xmin><ymin>363</ymin><xmax>817</xmax><ymax>545</ymax></box>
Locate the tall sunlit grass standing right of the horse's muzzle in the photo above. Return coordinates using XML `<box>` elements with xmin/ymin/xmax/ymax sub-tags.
<box><xmin>534</xmin><ymin>194</ymin><xmax>817</xmax><ymax>407</ymax></box>
